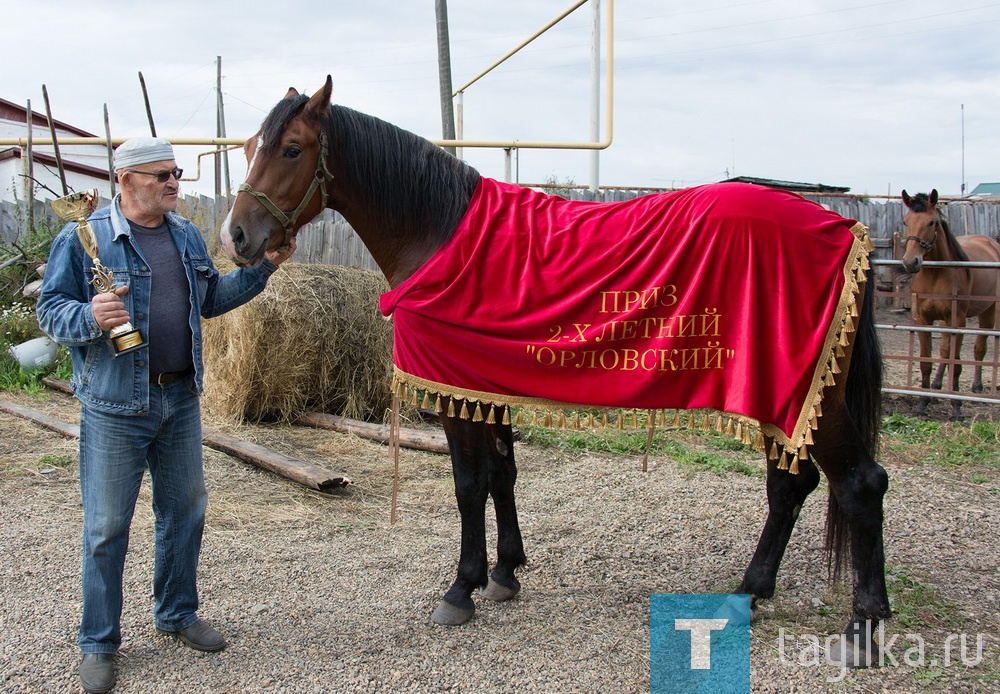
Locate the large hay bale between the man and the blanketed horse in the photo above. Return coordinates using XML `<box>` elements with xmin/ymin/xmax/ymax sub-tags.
<box><xmin>204</xmin><ymin>261</ymin><xmax>392</xmax><ymax>422</ymax></box>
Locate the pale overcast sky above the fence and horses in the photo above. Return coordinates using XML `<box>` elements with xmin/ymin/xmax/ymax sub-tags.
<box><xmin>7</xmin><ymin>0</ymin><xmax>1000</xmax><ymax>201</ymax></box>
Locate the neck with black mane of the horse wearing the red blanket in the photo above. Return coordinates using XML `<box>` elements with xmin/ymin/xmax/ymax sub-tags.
<box><xmin>328</xmin><ymin>113</ymin><xmax>479</xmax><ymax>287</ymax></box>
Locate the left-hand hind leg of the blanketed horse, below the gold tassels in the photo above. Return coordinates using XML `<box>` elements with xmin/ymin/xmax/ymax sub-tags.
<box><xmin>736</xmin><ymin>454</ymin><xmax>819</xmax><ymax>612</ymax></box>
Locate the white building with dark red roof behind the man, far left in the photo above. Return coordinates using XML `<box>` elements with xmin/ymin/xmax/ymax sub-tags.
<box><xmin>0</xmin><ymin>99</ymin><xmax>111</xmax><ymax>202</ymax></box>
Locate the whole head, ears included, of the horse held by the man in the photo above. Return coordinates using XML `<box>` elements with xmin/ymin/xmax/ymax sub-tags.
<box><xmin>220</xmin><ymin>76</ymin><xmax>333</xmax><ymax>266</ymax></box>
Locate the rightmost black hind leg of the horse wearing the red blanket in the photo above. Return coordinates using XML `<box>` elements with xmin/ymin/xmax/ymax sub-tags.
<box><xmin>811</xmin><ymin>406</ymin><xmax>891</xmax><ymax>667</ymax></box>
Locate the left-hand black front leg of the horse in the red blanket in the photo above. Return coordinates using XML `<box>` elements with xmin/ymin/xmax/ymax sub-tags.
<box><xmin>431</xmin><ymin>410</ymin><xmax>489</xmax><ymax>626</ymax></box>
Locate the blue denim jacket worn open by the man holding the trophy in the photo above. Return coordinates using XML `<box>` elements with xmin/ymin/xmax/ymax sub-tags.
<box><xmin>36</xmin><ymin>195</ymin><xmax>277</xmax><ymax>415</ymax></box>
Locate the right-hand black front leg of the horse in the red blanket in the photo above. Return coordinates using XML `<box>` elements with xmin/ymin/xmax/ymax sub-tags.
<box><xmin>483</xmin><ymin>424</ymin><xmax>526</xmax><ymax>601</ymax></box>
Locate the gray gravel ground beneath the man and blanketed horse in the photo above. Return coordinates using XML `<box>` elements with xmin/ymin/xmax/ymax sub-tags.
<box><xmin>0</xmin><ymin>320</ymin><xmax>1000</xmax><ymax>692</ymax></box>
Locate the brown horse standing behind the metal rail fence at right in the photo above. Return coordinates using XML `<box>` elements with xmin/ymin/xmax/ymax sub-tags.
<box><xmin>902</xmin><ymin>189</ymin><xmax>1000</xmax><ymax>420</ymax></box>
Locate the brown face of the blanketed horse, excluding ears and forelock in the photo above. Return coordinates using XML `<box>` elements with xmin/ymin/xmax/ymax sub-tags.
<box><xmin>220</xmin><ymin>117</ymin><xmax>322</xmax><ymax>267</ymax></box>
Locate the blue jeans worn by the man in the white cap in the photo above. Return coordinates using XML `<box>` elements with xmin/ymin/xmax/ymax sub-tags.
<box><xmin>79</xmin><ymin>377</ymin><xmax>208</xmax><ymax>653</ymax></box>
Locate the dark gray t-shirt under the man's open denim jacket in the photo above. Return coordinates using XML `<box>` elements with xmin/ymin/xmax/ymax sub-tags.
<box><xmin>129</xmin><ymin>221</ymin><xmax>191</xmax><ymax>375</ymax></box>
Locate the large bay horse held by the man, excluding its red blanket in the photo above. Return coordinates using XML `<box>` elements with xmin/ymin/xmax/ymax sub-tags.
<box><xmin>220</xmin><ymin>76</ymin><xmax>890</xmax><ymax>667</ymax></box>
